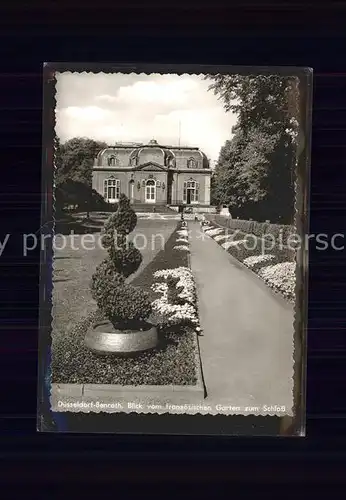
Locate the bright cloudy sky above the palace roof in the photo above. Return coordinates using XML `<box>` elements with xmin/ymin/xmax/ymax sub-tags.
<box><xmin>56</xmin><ymin>72</ymin><xmax>236</xmax><ymax>165</ymax></box>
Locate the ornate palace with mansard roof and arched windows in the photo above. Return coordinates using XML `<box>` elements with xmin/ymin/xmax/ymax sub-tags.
<box><xmin>92</xmin><ymin>140</ymin><xmax>212</xmax><ymax>208</ymax></box>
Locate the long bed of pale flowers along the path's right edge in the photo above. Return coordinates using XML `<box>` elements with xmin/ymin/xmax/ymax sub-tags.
<box><xmin>203</xmin><ymin>221</ymin><xmax>296</xmax><ymax>302</ymax></box>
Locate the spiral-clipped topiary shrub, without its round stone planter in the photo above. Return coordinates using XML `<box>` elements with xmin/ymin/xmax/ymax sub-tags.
<box><xmin>91</xmin><ymin>195</ymin><xmax>152</xmax><ymax>330</ymax></box>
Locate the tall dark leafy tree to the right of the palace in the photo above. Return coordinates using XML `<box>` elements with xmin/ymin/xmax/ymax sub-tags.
<box><xmin>207</xmin><ymin>75</ymin><xmax>298</xmax><ymax>223</ymax></box>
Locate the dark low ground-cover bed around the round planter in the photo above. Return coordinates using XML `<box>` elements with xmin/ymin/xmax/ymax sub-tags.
<box><xmin>52</xmin><ymin>222</ymin><xmax>197</xmax><ymax>386</ymax></box>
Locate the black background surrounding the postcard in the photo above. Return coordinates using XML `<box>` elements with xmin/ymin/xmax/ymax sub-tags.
<box><xmin>0</xmin><ymin>0</ymin><xmax>346</xmax><ymax>496</ymax></box>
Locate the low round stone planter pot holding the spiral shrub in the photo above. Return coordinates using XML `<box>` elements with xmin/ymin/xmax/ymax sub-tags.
<box><xmin>85</xmin><ymin>321</ymin><xmax>158</xmax><ymax>356</ymax></box>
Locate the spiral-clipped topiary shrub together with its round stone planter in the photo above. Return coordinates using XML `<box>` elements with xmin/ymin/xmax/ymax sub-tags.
<box><xmin>86</xmin><ymin>195</ymin><xmax>157</xmax><ymax>353</ymax></box>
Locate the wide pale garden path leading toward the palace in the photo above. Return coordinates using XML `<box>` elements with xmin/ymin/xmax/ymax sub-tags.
<box><xmin>189</xmin><ymin>222</ymin><xmax>294</xmax><ymax>410</ymax></box>
